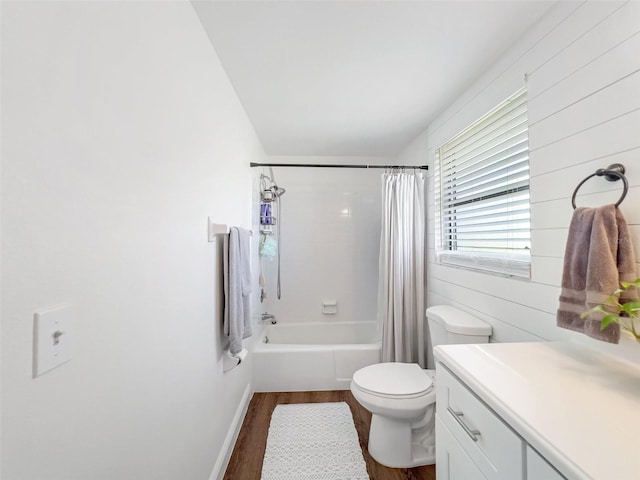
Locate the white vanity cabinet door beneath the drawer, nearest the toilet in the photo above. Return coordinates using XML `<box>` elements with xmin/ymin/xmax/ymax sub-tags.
<box><xmin>436</xmin><ymin>414</ymin><xmax>486</xmax><ymax>480</ymax></box>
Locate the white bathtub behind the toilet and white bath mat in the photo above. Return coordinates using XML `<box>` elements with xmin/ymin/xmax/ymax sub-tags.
<box><xmin>253</xmin><ymin>322</ymin><xmax>381</xmax><ymax>392</ymax></box>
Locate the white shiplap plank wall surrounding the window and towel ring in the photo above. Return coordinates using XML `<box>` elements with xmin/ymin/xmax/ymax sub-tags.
<box><xmin>397</xmin><ymin>2</ymin><xmax>640</xmax><ymax>362</ymax></box>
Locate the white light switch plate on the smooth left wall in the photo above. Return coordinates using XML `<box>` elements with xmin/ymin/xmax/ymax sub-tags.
<box><xmin>33</xmin><ymin>304</ymin><xmax>73</xmax><ymax>378</ymax></box>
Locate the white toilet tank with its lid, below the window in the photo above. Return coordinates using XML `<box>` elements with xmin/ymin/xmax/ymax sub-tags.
<box><xmin>427</xmin><ymin>305</ymin><xmax>491</xmax><ymax>348</ymax></box>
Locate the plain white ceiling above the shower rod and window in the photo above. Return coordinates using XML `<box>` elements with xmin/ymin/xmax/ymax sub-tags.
<box><xmin>191</xmin><ymin>0</ymin><xmax>554</xmax><ymax>156</ymax></box>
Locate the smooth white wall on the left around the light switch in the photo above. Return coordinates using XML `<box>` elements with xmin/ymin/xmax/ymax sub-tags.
<box><xmin>2</xmin><ymin>1</ymin><xmax>263</xmax><ymax>480</ymax></box>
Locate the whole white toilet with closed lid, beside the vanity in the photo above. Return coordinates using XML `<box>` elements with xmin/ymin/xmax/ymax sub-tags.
<box><xmin>351</xmin><ymin>305</ymin><xmax>491</xmax><ymax>468</ymax></box>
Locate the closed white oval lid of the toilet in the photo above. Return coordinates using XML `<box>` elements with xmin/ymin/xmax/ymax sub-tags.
<box><xmin>353</xmin><ymin>363</ymin><xmax>433</xmax><ymax>397</ymax></box>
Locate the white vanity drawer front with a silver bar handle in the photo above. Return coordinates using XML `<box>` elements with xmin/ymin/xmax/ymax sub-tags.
<box><xmin>436</xmin><ymin>363</ymin><xmax>525</xmax><ymax>480</ymax></box>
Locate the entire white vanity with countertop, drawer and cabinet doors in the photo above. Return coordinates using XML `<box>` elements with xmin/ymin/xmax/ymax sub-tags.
<box><xmin>434</xmin><ymin>342</ymin><xmax>640</xmax><ymax>480</ymax></box>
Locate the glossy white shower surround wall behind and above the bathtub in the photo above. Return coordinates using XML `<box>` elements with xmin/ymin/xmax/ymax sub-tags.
<box><xmin>254</xmin><ymin>156</ymin><xmax>387</xmax><ymax>322</ymax></box>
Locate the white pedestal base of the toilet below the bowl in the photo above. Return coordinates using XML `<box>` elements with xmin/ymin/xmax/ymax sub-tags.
<box><xmin>368</xmin><ymin>403</ymin><xmax>436</xmax><ymax>468</ymax></box>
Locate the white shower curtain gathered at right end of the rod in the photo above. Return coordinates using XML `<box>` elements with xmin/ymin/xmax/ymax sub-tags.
<box><xmin>378</xmin><ymin>172</ymin><xmax>425</xmax><ymax>362</ymax></box>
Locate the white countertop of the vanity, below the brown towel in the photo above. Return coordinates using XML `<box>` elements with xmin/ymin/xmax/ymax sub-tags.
<box><xmin>434</xmin><ymin>342</ymin><xmax>640</xmax><ymax>480</ymax></box>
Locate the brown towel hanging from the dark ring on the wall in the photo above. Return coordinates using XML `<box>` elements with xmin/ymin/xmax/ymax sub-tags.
<box><xmin>557</xmin><ymin>205</ymin><xmax>636</xmax><ymax>343</ymax></box>
